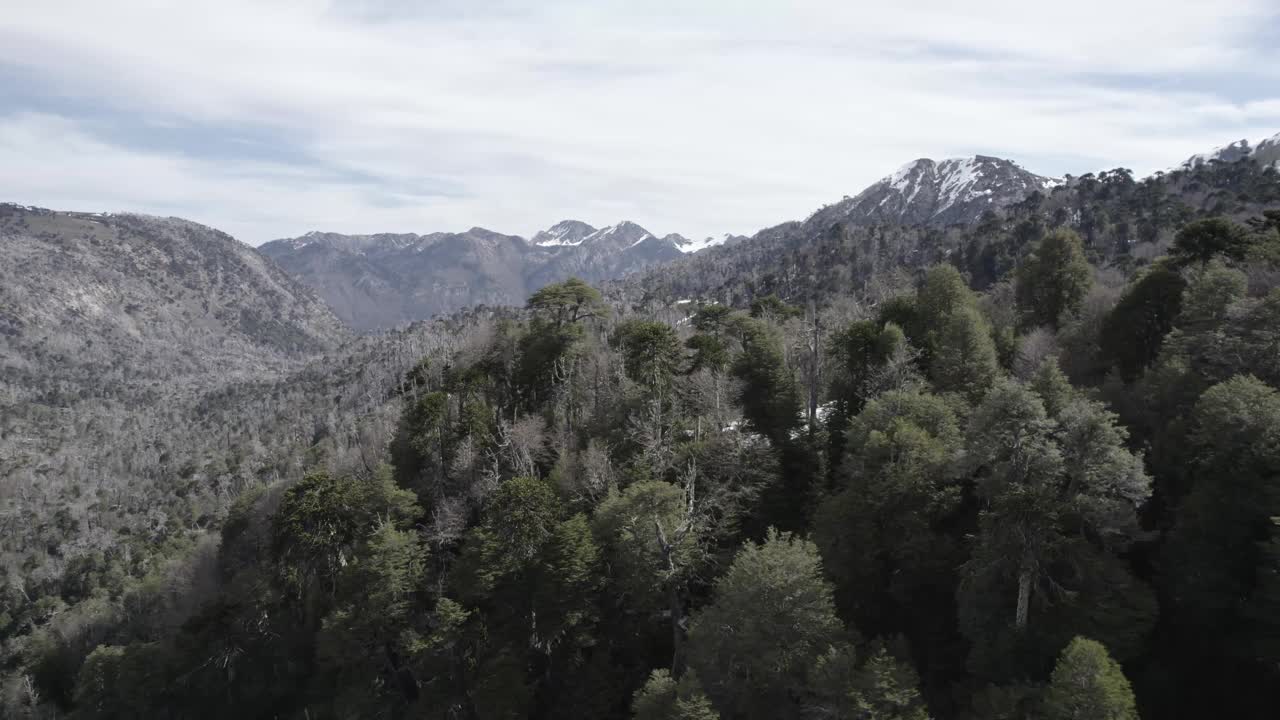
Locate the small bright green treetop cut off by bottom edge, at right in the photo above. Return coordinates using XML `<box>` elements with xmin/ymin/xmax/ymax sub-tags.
<box><xmin>1044</xmin><ymin>637</ymin><xmax>1138</xmax><ymax>720</ymax></box>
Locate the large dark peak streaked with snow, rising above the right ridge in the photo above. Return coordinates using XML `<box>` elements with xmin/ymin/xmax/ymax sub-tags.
<box><xmin>805</xmin><ymin>155</ymin><xmax>1061</xmax><ymax>225</ymax></box>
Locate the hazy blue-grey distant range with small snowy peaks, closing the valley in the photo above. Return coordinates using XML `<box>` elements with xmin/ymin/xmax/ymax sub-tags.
<box><xmin>259</xmin><ymin>220</ymin><xmax>691</xmax><ymax>332</ymax></box>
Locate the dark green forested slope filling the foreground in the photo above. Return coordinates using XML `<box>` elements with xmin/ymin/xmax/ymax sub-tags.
<box><xmin>0</xmin><ymin>163</ymin><xmax>1280</xmax><ymax>720</ymax></box>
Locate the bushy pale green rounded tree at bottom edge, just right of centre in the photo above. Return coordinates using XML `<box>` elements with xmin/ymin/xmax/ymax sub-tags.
<box><xmin>689</xmin><ymin>530</ymin><xmax>845</xmax><ymax>720</ymax></box>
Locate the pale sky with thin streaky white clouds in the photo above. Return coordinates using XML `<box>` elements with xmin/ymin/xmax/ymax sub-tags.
<box><xmin>0</xmin><ymin>0</ymin><xmax>1280</xmax><ymax>245</ymax></box>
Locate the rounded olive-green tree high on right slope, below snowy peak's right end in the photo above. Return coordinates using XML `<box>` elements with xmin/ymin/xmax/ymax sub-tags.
<box><xmin>1015</xmin><ymin>228</ymin><xmax>1093</xmax><ymax>329</ymax></box>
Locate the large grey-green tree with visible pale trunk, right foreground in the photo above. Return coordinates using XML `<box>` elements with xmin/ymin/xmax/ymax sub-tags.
<box><xmin>959</xmin><ymin>382</ymin><xmax>1155</xmax><ymax>680</ymax></box>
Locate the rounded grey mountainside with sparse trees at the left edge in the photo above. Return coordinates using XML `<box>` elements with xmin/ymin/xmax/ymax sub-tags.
<box><xmin>0</xmin><ymin>205</ymin><xmax>349</xmax><ymax>388</ymax></box>
